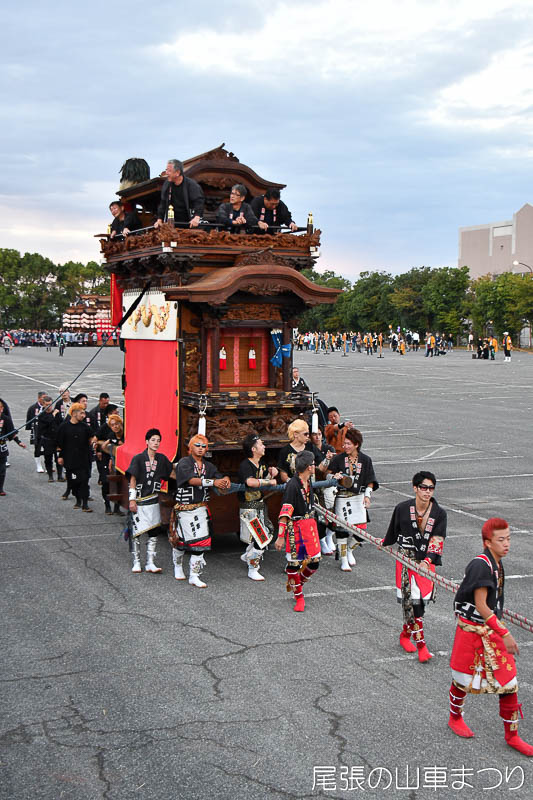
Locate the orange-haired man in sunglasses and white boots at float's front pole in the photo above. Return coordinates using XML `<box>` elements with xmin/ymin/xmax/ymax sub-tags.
<box><xmin>169</xmin><ymin>434</ymin><xmax>231</xmax><ymax>589</ymax></box>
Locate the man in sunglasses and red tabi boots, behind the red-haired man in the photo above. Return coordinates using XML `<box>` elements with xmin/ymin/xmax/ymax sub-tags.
<box><xmin>382</xmin><ymin>472</ymin><xmax>447</xmax><ymax>663</ymax></box>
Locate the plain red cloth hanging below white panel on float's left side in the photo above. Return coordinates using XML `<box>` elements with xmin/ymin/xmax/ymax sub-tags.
<box><xmin>117</xmin><ymin>339</ymin><xmax>179</xmax><ymax>472</ymax></box>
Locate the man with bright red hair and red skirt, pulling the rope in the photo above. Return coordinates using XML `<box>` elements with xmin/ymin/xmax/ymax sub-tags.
<box><xmin>448</xmin><ymin>517</ymin><xmax>533</xmax><ymax>756</ymax></box>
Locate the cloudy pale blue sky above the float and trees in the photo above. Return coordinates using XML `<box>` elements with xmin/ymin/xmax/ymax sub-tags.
<box><xmin>0</xmin><ymin>0</ymin><xmax>533</xmax><ymax>278</ymax></box>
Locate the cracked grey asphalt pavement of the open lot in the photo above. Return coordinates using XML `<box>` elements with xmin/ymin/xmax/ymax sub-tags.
<box><xmin>0</xmin><ymin>340</ymin><xmax>533</xmax><ymax>800</ymax></box>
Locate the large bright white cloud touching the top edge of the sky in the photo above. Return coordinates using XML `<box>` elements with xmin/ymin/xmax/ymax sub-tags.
<box><xmin>152</xmin><ymin>0</ymin><xmax>533</xmax><ymax>83</ymax></box>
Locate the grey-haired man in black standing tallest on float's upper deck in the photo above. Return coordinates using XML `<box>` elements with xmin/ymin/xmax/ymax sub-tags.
<box><xmin>154</xmin><ymin>158</ymin><xmax>205</xmax><ymax>228</ymax></box>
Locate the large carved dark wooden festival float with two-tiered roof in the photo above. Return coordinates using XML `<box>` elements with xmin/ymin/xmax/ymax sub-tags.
<box><xmin>100</xmin><ymin>145</ymin><xmax>339</xmax><ymax>533</ymax></box>
